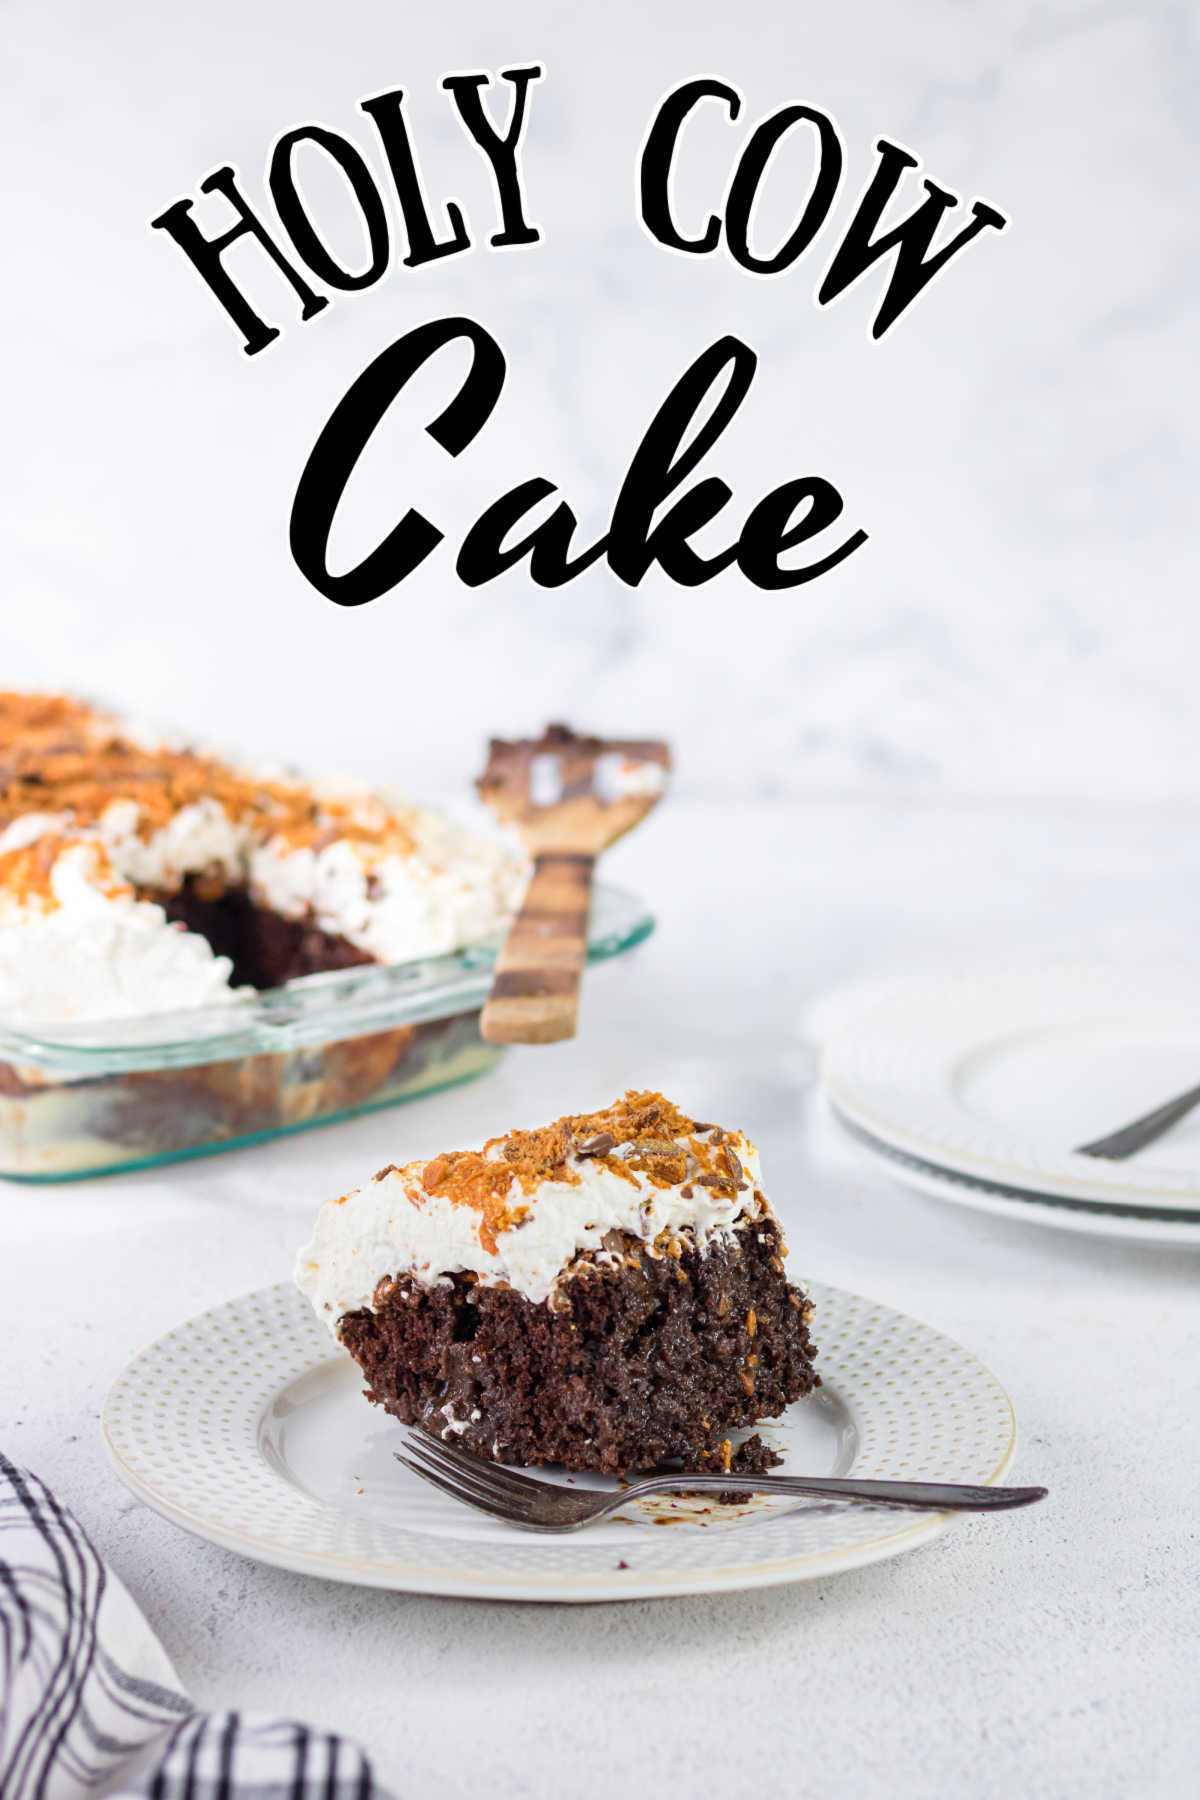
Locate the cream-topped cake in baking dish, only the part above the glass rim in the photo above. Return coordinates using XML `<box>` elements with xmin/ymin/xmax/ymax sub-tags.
<box><xmin>0</xmin><ymin>693</ymin><xmax>527</xmax><ymax>1022</ymax></box>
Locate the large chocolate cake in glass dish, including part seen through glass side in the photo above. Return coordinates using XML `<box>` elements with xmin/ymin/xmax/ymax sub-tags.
<box><xmin>0</xmin><ymin>693</ymin><xmax>527</xmax><ymax>1179</ymax></box>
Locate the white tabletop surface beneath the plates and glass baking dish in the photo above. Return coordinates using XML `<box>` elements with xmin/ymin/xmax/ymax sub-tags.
<box><xmin>0</xmin><ymin>801</ymin><xmax>1200</xmax><ymax>1800</ymax></box>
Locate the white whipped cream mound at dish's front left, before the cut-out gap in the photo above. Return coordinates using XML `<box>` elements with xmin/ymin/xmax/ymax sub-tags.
<box><xmin>0</xmin><ymin>842</ymin><xmax>237</xmax><ymax>1024</ymax></box>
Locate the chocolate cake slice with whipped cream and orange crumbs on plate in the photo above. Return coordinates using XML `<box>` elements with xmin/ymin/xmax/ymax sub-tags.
<box><xmin>297</xmin><ymin>1093</ymin><xmax>817</xmax><ymax>1474</ymax></box>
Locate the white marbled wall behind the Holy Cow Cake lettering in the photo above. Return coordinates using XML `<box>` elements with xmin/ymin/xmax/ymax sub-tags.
<box><xmin>0</xmin><ymin>0</ymin><xmax>1200</xmax><ymax>797</ymax></box>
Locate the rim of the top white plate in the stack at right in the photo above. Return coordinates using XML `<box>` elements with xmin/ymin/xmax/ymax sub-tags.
<box><xmin>819</xmin><ymin>959</ymin><xmax>1200</xmax><ymax>1222</ymax></box>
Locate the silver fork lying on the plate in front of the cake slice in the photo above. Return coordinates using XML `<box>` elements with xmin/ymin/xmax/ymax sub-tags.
<box><xmin>392</xmin><ymin>1426</ymin><xmax>1047</xmax><ymax>1532</ymax></box>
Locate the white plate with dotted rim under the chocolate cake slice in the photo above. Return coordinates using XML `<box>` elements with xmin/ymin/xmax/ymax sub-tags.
<box><xmin>103</xmin><ymin>1283</ymin><xmax>1015</xmax><ymax>1600</ymax></box>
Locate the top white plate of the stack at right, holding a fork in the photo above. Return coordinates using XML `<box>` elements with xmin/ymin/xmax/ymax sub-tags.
<box><xmin>820</xmin><ymin>963</ymin><xmax>1200</xmax><ymax>1222</ymax></box>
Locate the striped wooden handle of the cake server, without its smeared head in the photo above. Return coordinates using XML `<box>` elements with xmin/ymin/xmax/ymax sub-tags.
<box><xmin>480</xmin><ymin>851</ymin><xmax>596</xmax><ymax>1044</ymax></box>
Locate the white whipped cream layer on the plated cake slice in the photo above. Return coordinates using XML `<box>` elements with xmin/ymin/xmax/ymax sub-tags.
<box><xmin>295</xmin><ymin>1134</ymin><xmax>761</xmax><ymax>1337</ymax></box>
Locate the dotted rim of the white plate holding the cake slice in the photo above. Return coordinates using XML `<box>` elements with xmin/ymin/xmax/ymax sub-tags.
<box><xmin>99</xmin><ymin>1282</ymin><xmax>1018</xmax><ymax>1604</ymax></box>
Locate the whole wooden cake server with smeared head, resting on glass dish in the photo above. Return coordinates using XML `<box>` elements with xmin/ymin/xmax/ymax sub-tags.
<box><xmin>477</xmin><ymin>725</ymin><xmax>671</xmax><ymax>1044</ymax></box>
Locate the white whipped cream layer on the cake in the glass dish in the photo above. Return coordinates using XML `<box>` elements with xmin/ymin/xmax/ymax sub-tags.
<box><xmin>0</xmin><ymin>794</ymin><xmax>529</xmax><ymax>1022</ymax></box>
